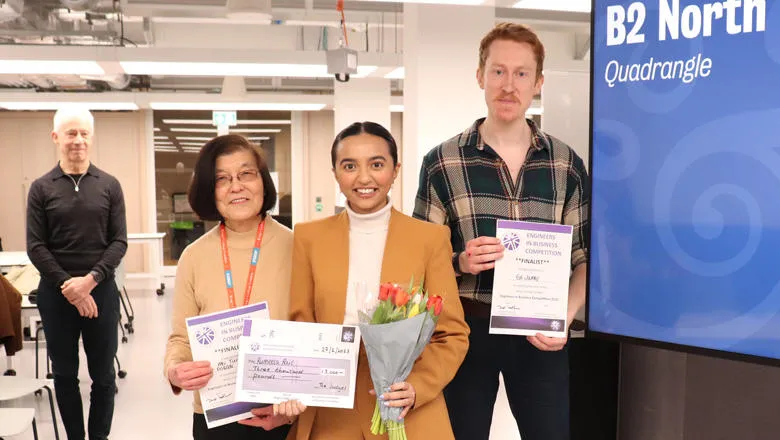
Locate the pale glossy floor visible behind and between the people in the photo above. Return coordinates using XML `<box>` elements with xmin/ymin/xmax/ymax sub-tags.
<box><xmin>0</xmin><ymin>278</ymin><xmax>520</xmax><ymax>440</ymax></box>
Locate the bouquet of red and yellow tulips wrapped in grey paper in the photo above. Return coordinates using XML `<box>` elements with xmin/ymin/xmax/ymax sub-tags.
<box><xmin>359</xmin><ymin>280</ymin><xmax>443</xmax><ymax>440</ymax></box>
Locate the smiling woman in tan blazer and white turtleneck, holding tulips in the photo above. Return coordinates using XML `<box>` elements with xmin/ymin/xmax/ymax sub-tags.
<box><xmin>279</xmin><ymin>122</ymin><xmax>469</xmax><ymax>440</ymax></box>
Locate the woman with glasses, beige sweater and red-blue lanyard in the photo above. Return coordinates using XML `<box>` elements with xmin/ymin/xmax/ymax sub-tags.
<box><xmin>165</xmin><ymin>135</ymin><xmax>293</xmax><ymax>440</ymax></box>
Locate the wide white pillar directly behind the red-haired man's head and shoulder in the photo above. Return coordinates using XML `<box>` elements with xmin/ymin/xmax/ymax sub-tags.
<box><xmin>402</xmin><ymin>4</ymin><xmax>495</xmax><ymax>215</ymax></box>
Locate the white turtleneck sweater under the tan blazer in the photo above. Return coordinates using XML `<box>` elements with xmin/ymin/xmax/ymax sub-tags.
<box><xmin>344</xmin><ymin>200</ymin><xmax>392</xmax><ymax>324</ymax></box>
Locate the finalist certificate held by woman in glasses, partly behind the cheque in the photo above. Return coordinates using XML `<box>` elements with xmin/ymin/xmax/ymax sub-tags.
<box><xmin>187</xmin><ymin>302</ymin><xmax>270</xmax><ymax>429</ymax></box>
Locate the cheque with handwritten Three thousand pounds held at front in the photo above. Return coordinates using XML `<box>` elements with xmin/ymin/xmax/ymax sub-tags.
<box><xmin>236</xmin><ymin>320</ymin><xmax>360</xmax><ymax>408</ymax></box>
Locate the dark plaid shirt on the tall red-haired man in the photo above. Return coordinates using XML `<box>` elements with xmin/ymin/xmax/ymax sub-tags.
<box><xmin>413</xmin><ymin>118</ymin><xmax>590</xmax><ymax>303</ymax></box>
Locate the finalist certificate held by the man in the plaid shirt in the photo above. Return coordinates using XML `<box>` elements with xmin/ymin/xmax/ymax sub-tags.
<box><xmin>490</xmin><ymin>220</ymin><xmax>573</xmax><ymax>337</ymax></box>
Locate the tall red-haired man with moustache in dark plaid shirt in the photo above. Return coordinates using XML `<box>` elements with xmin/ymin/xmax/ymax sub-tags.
<box><xmin>414</xmin><ymin>23</ymin><xmax>590</xmax><ymax>440</ymax></box>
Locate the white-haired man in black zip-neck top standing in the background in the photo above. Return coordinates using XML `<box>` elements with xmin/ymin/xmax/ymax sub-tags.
<box><xmin>27</xmin><ymin>108</ymin><xmax>127</xmax><ymax>440</ymax></box>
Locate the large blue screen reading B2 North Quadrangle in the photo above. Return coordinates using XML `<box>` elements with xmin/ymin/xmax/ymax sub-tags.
<box><xmin>587</xmin><ymin>0</ymin><xmax>780</xmax><ymax>363</ymax></box>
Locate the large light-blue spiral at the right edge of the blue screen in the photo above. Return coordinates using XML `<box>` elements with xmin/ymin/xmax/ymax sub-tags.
<box><xmin>653</xmin><ymin>110</ymin><xmax>780</xmax><ymax>277</ymax></box>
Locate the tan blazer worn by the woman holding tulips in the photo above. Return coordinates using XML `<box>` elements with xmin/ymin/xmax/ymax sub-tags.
<box><xmin>288</xmin><ymin>209</ymin><xmax>469</xmax><ymax>440</ymax></box>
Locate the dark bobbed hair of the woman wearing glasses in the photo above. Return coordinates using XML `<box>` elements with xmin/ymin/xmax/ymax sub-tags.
<box><xmin>187</xmin><ymin>134</ymin><xmax>276</xmax><ymax>221</ymax></box>
